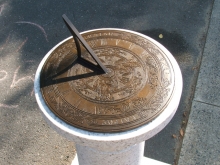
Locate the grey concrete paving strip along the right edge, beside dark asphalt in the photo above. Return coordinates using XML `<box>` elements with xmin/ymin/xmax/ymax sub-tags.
<box><xmin>179</xmin><ymin>0</ymin><xmax>220</xmax><ymax>165</ymax></box>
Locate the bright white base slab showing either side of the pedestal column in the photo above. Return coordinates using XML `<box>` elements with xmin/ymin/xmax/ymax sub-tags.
<box><xmin>71</xmin><ymin>154</ymin><xmax>170</xmax><ymax>165</ymax></box>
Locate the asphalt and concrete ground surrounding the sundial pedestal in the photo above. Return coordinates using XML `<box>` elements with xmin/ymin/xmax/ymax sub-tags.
<box><xmin>0</xmin><ymin>0</ymin><xmax>217</xmax><ymax>165</ymax></box>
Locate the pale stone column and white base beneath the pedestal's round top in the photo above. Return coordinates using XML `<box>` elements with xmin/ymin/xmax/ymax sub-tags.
<box><xmin>71</xmin><ymin>141</ymin><xmax>168</xmax><ymax>165</ymax></box>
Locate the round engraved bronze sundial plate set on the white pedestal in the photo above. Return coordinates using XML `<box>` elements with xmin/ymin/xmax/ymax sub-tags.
<box><xmin>40</xmin><ymin>14</ymin><xmax>175</xmax><ymax>133</ymax></box>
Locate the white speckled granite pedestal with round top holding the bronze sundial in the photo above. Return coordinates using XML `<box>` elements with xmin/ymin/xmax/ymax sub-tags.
<box><xmin>34</xmin><ymin>29</ymin><xmax>182</xmax><ymax>165</ymax></box>
